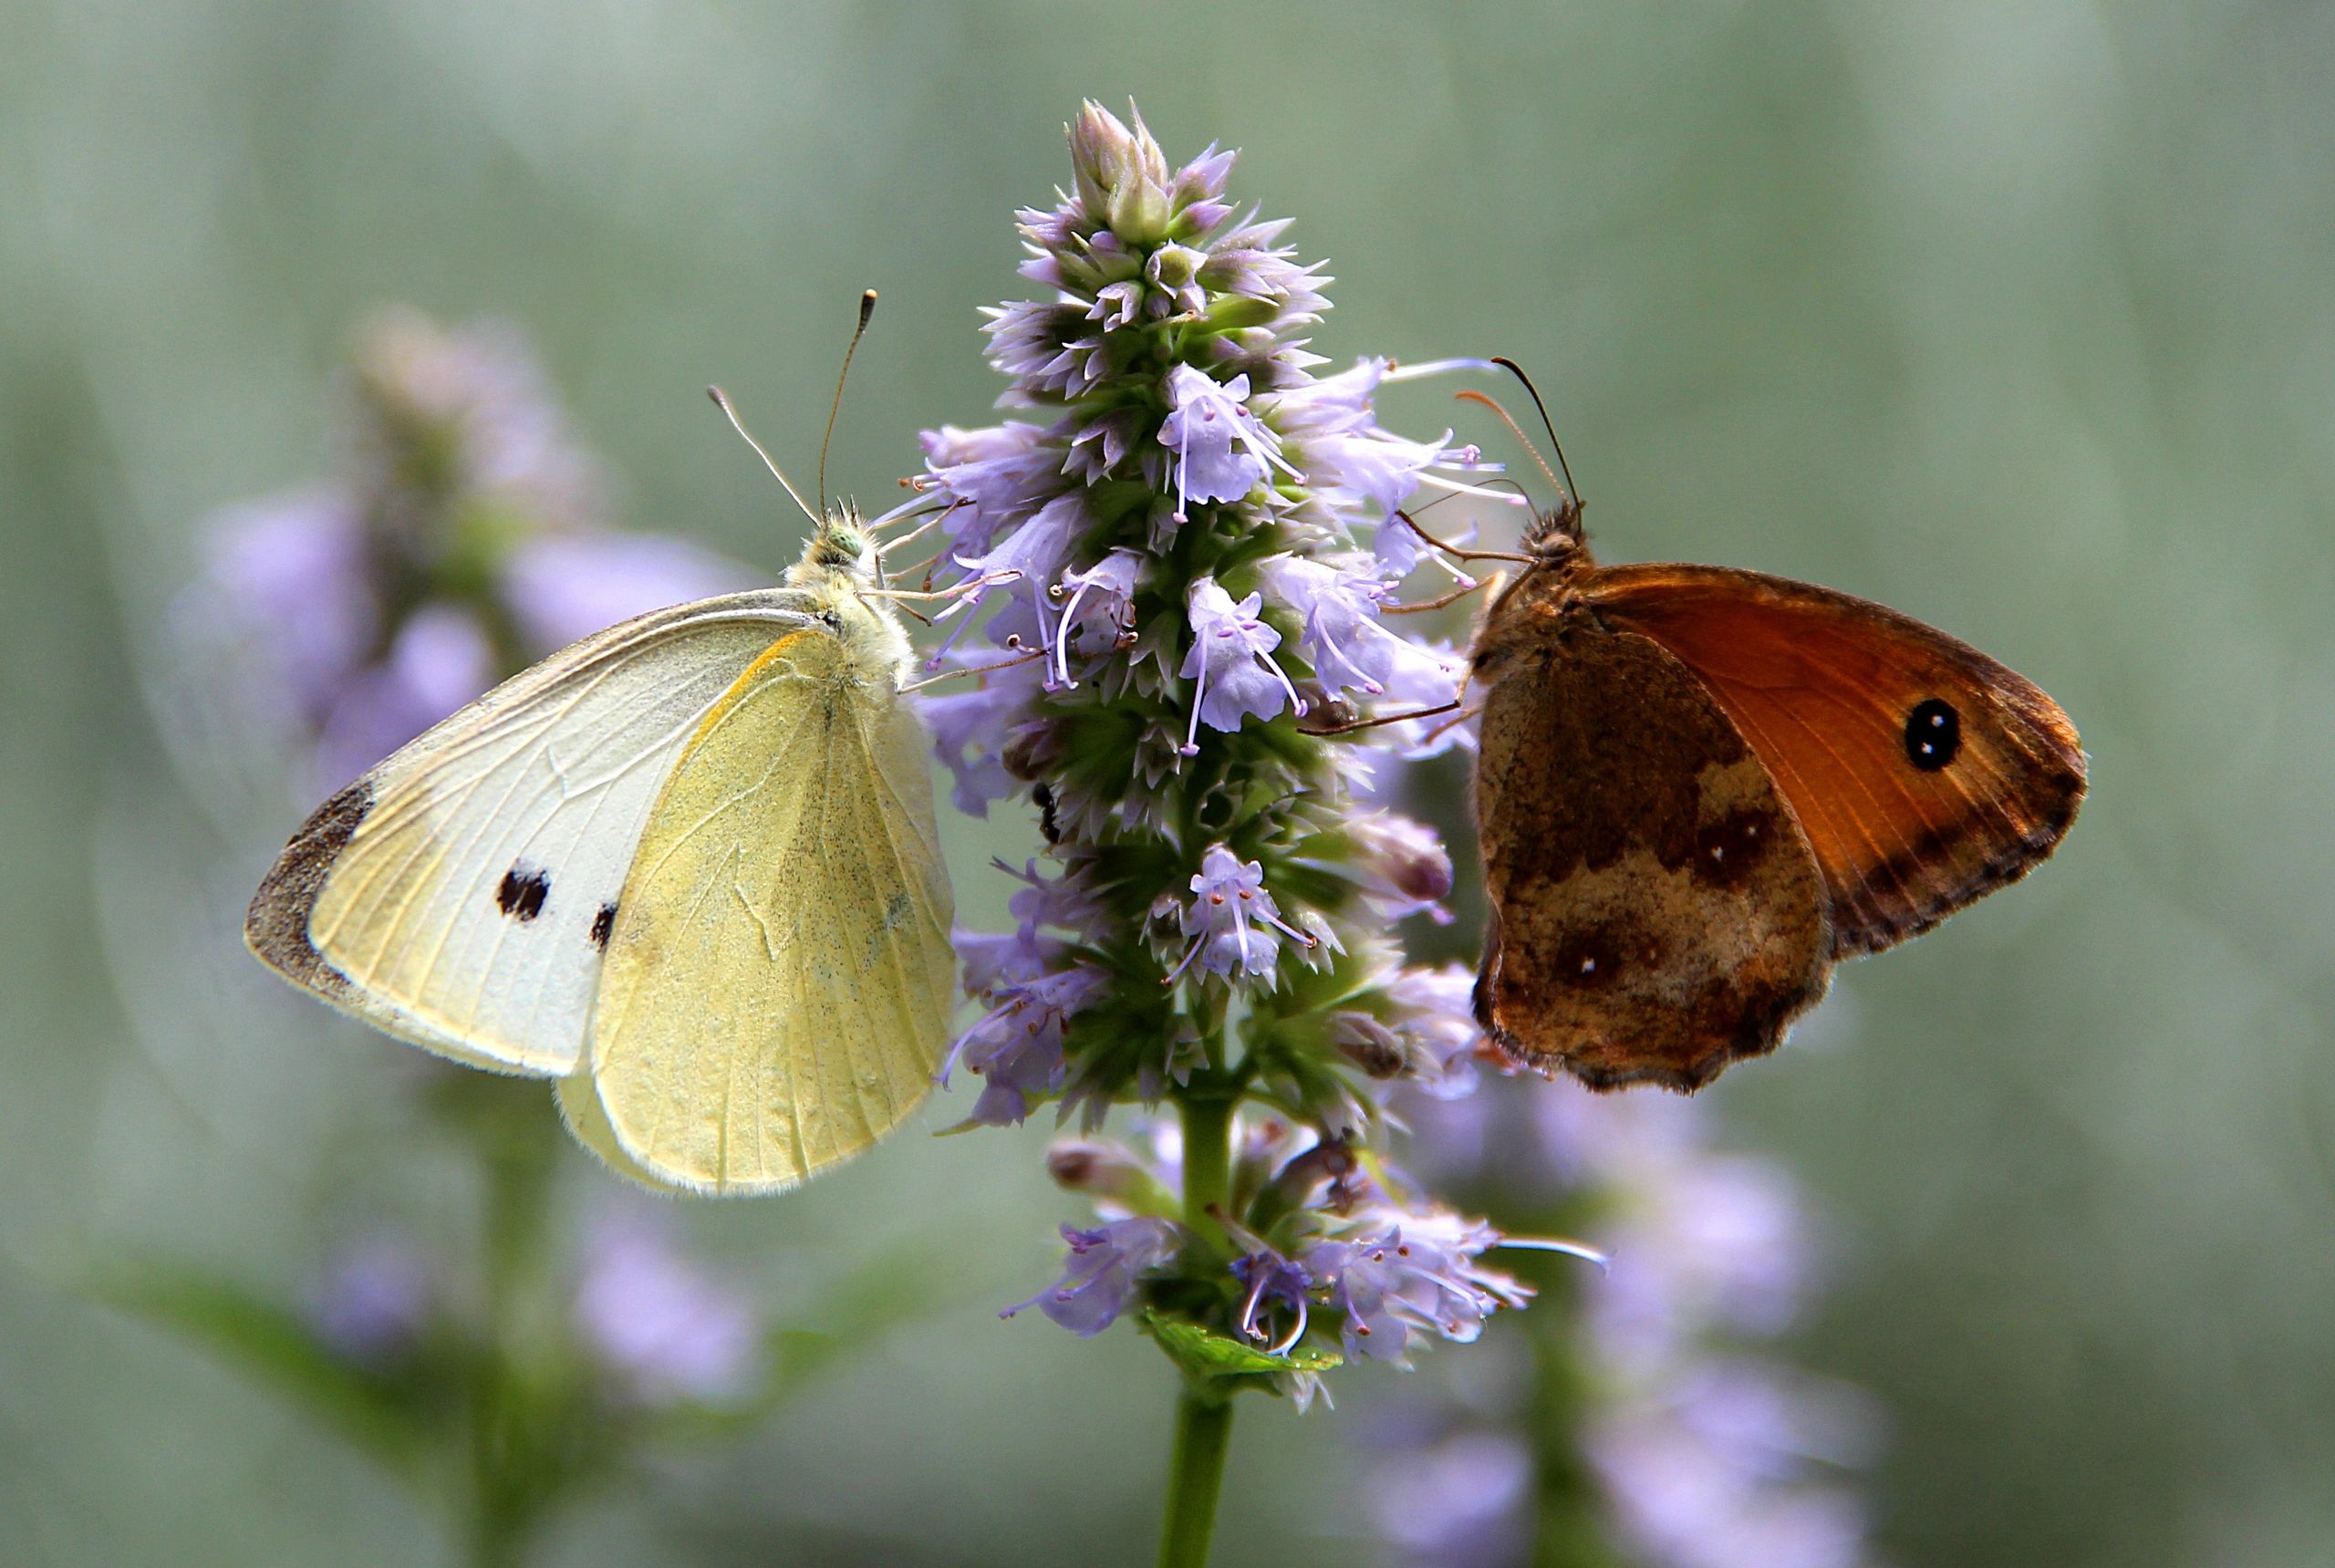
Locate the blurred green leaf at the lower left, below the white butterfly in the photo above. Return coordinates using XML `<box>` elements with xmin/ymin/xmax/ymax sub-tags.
<box><xmin>91</xmin><ymin>1260</ymin><xmax>432</xmax><ymax>1477</ymax></box>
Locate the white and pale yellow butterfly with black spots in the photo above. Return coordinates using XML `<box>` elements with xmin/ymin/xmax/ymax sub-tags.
<box><xmin>245</xmin><ymin>512</ymin><xmax>955</xmax><ymax>1192</ymax></box>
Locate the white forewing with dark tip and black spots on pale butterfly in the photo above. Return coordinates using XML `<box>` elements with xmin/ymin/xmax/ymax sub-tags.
<box><xmin>245</xmin><ymin>589</ymin><xmax>813</xmax><ymax>1075</ymax></box>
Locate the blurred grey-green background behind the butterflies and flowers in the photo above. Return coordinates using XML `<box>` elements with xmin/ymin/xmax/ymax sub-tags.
<box><xmin>0</xmin><ymin>0</ymin><xmax>2335</xmax><ymax>1568</ymax></box>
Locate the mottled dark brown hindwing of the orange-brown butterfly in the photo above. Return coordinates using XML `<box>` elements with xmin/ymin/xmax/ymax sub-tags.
<box><xmin>1476</xmin><ymin>617</ymin><xmax>1831</xmax><ymax>1089</ymax></box>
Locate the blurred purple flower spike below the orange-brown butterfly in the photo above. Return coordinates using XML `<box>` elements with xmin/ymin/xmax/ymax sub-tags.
<box><xmin>1364</xmin><ymin>1079</ymin><xmax>1880</xmax><ymax>1568</ymax></box>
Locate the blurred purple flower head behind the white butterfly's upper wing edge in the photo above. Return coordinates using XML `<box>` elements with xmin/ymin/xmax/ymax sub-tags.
<box><xmin>172</xmin><ymin>313</ymin><xmax>752</xmax><ymax>794</ymax></box>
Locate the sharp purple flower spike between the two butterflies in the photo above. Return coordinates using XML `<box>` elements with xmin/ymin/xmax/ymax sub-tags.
<box><xmin>894</xmin><ymin>105</ymin><xmax>1597</xmax><ymax>1407</ymax></box>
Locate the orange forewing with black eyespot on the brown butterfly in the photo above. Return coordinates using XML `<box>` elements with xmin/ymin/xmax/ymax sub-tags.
<box><xmin>1581</xmin><ymin>563</ymin><xmax>2085</xmax><ymax>956</ymax></box>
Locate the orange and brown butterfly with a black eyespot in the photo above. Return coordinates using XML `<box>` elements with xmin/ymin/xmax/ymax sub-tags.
<box><xmin>1406</xmin><ymin>360</ymin><xmax>2085</xmax><ymax>1091</ymax></box>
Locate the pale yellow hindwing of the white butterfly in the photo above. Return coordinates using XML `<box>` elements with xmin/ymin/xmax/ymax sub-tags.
<box><xmin>578</xmin><ymin>627</ymin><xmax>955</xmax><ymax>1192</ymax></box>
